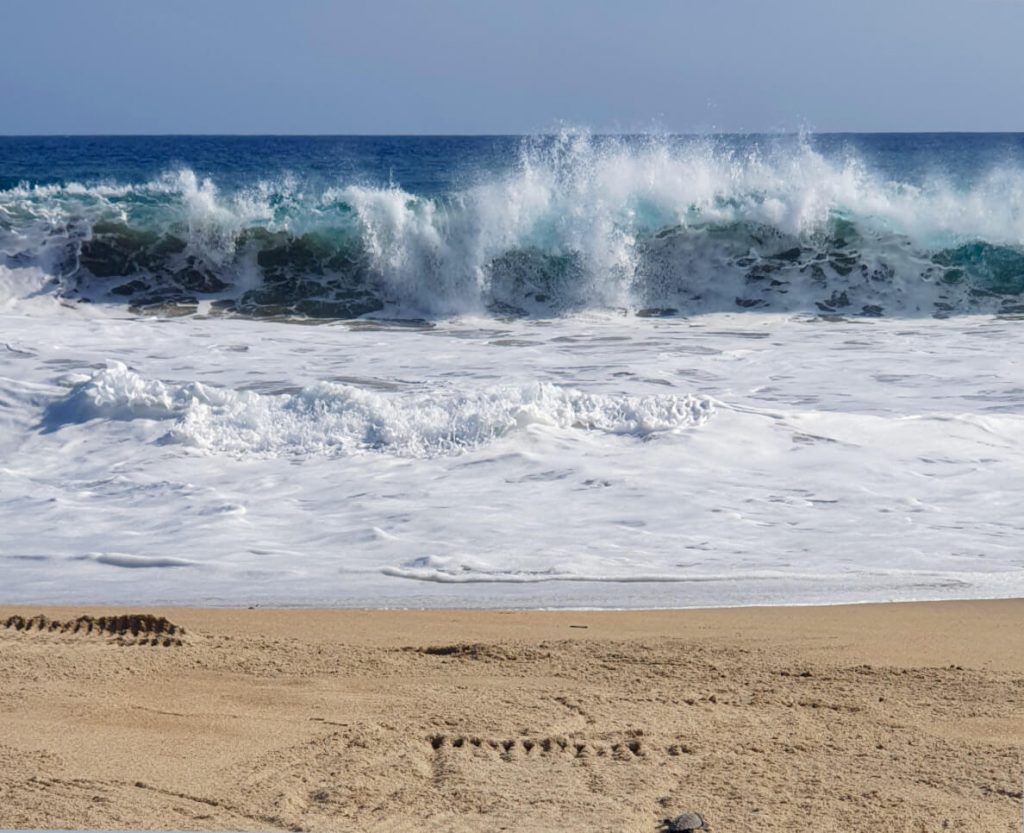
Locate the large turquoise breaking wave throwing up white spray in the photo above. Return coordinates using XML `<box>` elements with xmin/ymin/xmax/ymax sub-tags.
<box><xmin>0</xmin><ymin>132</ymin><xmax>1024</xmax><ymax>318</ymax></box>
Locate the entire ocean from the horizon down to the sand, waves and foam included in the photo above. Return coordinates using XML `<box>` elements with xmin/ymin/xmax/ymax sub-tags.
<box><xmin>0</xmin><ymin>130</ymin><xmax>1024</xmax><ymax>608</ymax></box>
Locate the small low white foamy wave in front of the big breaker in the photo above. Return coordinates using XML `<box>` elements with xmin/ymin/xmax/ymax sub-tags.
<box><xmin>42</xmin><ymin>362</ymin><xmax>714</xmax><ymax>457</ymax></box>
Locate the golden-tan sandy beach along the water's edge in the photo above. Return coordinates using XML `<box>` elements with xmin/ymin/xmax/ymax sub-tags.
<box><xmin>0</xmin><ymin>600</ymin><xmax>1024</xmax><ymax>833</ymax></box>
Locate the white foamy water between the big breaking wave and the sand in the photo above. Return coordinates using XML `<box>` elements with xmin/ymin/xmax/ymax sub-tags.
<box><xmin>0</xmin><ymin>309</ymin><xmax>1024</xmax><ymax>607</ymax></box>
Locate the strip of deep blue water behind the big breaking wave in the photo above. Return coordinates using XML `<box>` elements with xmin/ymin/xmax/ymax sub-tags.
<box><xmin>6</xmin><ymin>133</ymin><xmax>1024</xmax><ymax>190</ymax></box>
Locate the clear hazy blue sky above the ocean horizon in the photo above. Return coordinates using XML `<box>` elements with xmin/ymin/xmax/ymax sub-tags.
<box><xmin>0</xmin><ymin>0</ymin><xmax>1024</xmax><ymax>134</ymax></box>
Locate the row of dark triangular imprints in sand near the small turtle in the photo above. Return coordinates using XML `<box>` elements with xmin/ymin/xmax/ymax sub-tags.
<box><xmin>429</xmin><ymin>735</ymin><xmax>693</xmax><ymax>761</ymax></box>
